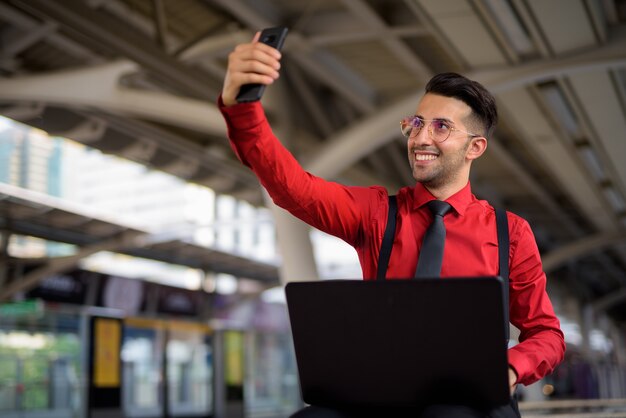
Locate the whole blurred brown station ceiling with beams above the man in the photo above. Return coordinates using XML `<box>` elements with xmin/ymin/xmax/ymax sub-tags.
<box><xmin>0</xmin><ymin>0</ymin><xmax>626</xmax><ymax>319</ymax></box>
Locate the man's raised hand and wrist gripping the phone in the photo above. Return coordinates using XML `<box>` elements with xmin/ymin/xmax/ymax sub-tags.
<box><xmin>222</xmin><ymin>32</ymin><xmax>281</xmax><ymax>106</ymax></box>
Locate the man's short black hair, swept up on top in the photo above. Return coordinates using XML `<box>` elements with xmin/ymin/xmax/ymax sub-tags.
<box><xmin>425</xmin><ymin>73</ymin><xmax>498</xmax><ymax>138</ymax></box>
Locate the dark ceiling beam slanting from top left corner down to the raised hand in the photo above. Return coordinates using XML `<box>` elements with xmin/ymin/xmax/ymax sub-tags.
<box><xmin>11</xmin><ymin>0</ymin><xmax>215</xmax><ymax>100</ymax></box>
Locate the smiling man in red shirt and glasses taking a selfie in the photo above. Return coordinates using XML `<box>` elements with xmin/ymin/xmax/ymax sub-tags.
<box><xmin>219</xmin><ymin>34</ymin><xmax>565</xmax><ymax>417</ymax></box>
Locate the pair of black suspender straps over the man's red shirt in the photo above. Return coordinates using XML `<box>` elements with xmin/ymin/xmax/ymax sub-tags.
<box><xmin>376</xmin><ymin>196</ymin><xmax>509</xmax><ymax>341</ymax></box>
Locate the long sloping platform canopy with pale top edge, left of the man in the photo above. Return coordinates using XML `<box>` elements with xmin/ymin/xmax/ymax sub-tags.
<box><xmin>0</xmin><ymin>183</ymin><xmax>278</xmax><ymax>300</ymax></box>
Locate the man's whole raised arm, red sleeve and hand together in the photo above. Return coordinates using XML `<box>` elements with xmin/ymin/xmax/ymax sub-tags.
<box><xmin>219</xmin><ymin>34</ymin><xmax>387</xmax><ymax>246</ymax></box>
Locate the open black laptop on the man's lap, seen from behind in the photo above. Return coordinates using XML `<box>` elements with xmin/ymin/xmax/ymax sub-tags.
<box><xmin>285</xmin><ymin>277</ymin><xmax>510</xmax><ymax>408</ymax></box>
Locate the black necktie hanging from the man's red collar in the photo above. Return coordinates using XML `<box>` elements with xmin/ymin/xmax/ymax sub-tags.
<box><xmin>415</xmin><ymin>200</ymin><xmax>452</xmax><ymax>277</ymax></box>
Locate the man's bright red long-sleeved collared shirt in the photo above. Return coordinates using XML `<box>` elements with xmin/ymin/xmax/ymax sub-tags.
<box><xmin>219</xmin><ymin>100</ymin><xmax>565</xmax><ymax>385</ymax></box>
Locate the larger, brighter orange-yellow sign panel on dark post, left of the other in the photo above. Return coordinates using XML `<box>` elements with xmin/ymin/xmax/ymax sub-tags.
<box><xmin>93</xmin><ymin>318</ymin><xmax>122</xmax><ymax>388</ymax></box>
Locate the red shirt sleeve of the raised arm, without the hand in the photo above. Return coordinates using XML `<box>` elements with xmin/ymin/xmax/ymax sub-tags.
<box><xmin>218</xmin><ymin>97</ymin><xmax>387</xmax><ymax>247</ymax></box>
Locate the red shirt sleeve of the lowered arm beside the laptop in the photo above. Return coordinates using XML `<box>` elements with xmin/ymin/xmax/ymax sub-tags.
<box><xmin>508</xmin><ymin>214</ymin><xmax>565</xmax><ymax>385</ymax></box>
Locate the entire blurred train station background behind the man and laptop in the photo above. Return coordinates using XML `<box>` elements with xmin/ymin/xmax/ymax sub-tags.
<box><xmin>0</xmin><ymin>0</ymin><xmax>626</xmax><ymax>418</ymax></box>
